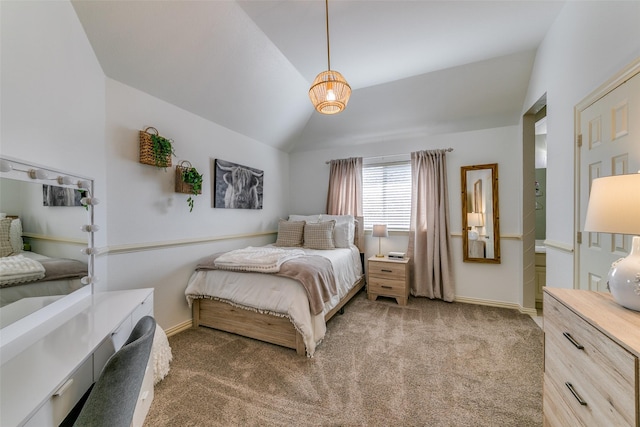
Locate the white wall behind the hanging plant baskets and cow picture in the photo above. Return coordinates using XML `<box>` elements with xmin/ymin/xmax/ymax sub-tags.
<box><xmin>103</xmin><ymin>79</ymin><xmax>289</xmax><ymax>328</ymax></box>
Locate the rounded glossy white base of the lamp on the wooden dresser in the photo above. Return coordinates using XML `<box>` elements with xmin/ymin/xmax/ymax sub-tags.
<box><xmin>609</xmin><ymin>236</ymin><xmax>640</xmax><ymax>311</ymax></box>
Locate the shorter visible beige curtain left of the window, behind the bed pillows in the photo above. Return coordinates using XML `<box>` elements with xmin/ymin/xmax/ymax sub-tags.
<box><xmin>327</xmin><ymin>157</ymin><xmax>362</xmax><ymax>216</ymax></box>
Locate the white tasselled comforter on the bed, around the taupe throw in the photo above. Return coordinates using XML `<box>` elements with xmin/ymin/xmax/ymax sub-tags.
<box><xmin>185</xmin><ymin>245</ymin><xmax>362</xmax><ymax>357</ymax></box>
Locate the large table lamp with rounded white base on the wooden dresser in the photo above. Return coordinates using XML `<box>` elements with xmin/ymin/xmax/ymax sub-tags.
<box><xmin>584</xmin><ymin>173</ymin><xmax>640</xmax><ymax>311</ymax></box>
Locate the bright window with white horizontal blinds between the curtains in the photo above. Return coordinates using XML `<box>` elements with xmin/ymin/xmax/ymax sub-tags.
<box><xmin>362</xmin><ymin>161</ymin><xmax>411</xmax><ymax>230</ymax></box>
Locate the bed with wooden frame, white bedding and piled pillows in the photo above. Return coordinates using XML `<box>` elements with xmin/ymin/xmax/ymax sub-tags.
<box><xmin>185</xmin><ymin>214</ymin><xmax>365</xmax><ymax>357</ymax></box>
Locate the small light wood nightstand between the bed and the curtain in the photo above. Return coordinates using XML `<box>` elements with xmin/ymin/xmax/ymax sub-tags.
<box><xmin>367</xmin><ymin>256</ymin><xmax>409</xmax><ymax>305</ymax></box>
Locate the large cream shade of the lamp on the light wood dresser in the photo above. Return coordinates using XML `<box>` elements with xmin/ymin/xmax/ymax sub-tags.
<box><xmin>584</xmin><ymin>173</ymin><xmax>640</xmax><ymax>235</ymax></box>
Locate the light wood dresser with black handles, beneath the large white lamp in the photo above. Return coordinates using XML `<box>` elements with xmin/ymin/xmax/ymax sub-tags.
<box><xmin>543</xmin><ymin>288</ymin><xmax>640</xmax><ymax>427</ymax></box>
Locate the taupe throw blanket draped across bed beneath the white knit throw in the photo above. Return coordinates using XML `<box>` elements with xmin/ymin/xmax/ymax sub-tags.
<box><xmin>196</xmin><ymin>253</ymin><xmax>338</xmax><ymax>316</ymax></box>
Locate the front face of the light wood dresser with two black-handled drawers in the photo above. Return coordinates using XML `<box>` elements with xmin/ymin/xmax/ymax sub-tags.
<box><xmin>544</xmin><ymin>295</ymin><xmax>637</xmax><ymax>426</ymax></box>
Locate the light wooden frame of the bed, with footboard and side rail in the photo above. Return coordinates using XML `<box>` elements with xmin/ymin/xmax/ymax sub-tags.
<box><xmin>192</xmin><ymin>217</ymin><xmax>365</xmax><ymax>356</ymax></box>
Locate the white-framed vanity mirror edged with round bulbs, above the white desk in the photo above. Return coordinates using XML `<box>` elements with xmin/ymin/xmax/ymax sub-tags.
<box><xmin>0</xmin><ymin>157</ymin><xmax>97</xmax><ymax>332</ymax></box>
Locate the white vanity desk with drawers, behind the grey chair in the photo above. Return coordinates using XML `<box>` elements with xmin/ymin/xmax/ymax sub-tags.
<box><xmin>0</xmin><ymin>289</ymin><xmax>153</xmax><ymax>427</ymax></box>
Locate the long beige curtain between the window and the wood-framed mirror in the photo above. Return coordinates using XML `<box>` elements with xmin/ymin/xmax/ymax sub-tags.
<box><xmin>407</xmin><ymin>150</ymin><xmax>455</xmax><ymax>302</ymax></box>
